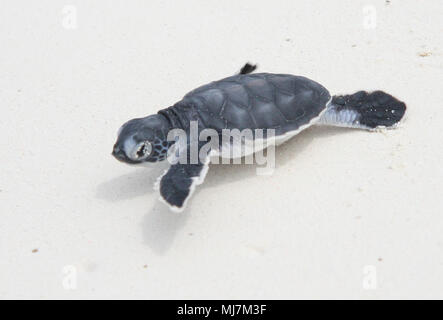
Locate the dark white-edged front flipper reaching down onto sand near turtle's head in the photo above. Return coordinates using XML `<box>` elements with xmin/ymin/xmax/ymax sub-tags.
<box><xmin>160</xmin><ymin>159</ymin><xmax>209</xmax><ymax>212</ymax></box>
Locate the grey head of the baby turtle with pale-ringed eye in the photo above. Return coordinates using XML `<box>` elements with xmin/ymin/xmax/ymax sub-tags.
<box><xmin>112</xmin><ymin>114</ymin><xmax>172</xmax><ymax>164</ymax></box>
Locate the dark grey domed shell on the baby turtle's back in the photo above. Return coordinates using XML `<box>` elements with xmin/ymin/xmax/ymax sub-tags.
<box><xmin>180</xmin><ymin>73</ymin><xmax>331</xmax><ymax>135</ymax></box>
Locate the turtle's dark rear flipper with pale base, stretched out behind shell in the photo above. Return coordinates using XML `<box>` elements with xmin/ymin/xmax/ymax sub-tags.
<box><xmin>319</xmin><ymin>91</ymin><xmax>406</xmax><ymax>130</ymax></box>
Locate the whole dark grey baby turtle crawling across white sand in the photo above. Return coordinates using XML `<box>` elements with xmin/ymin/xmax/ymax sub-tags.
<box><xmin>112</xmin><ymin>64</ymin><xmax>406</xmax><ymax>211</ymax></box>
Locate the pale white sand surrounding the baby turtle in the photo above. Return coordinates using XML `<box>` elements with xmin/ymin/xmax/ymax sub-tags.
<box><xmin>0</xmin><ymin>0</ymin><xmax>443</xmax><ymax>299</ymax></box>
